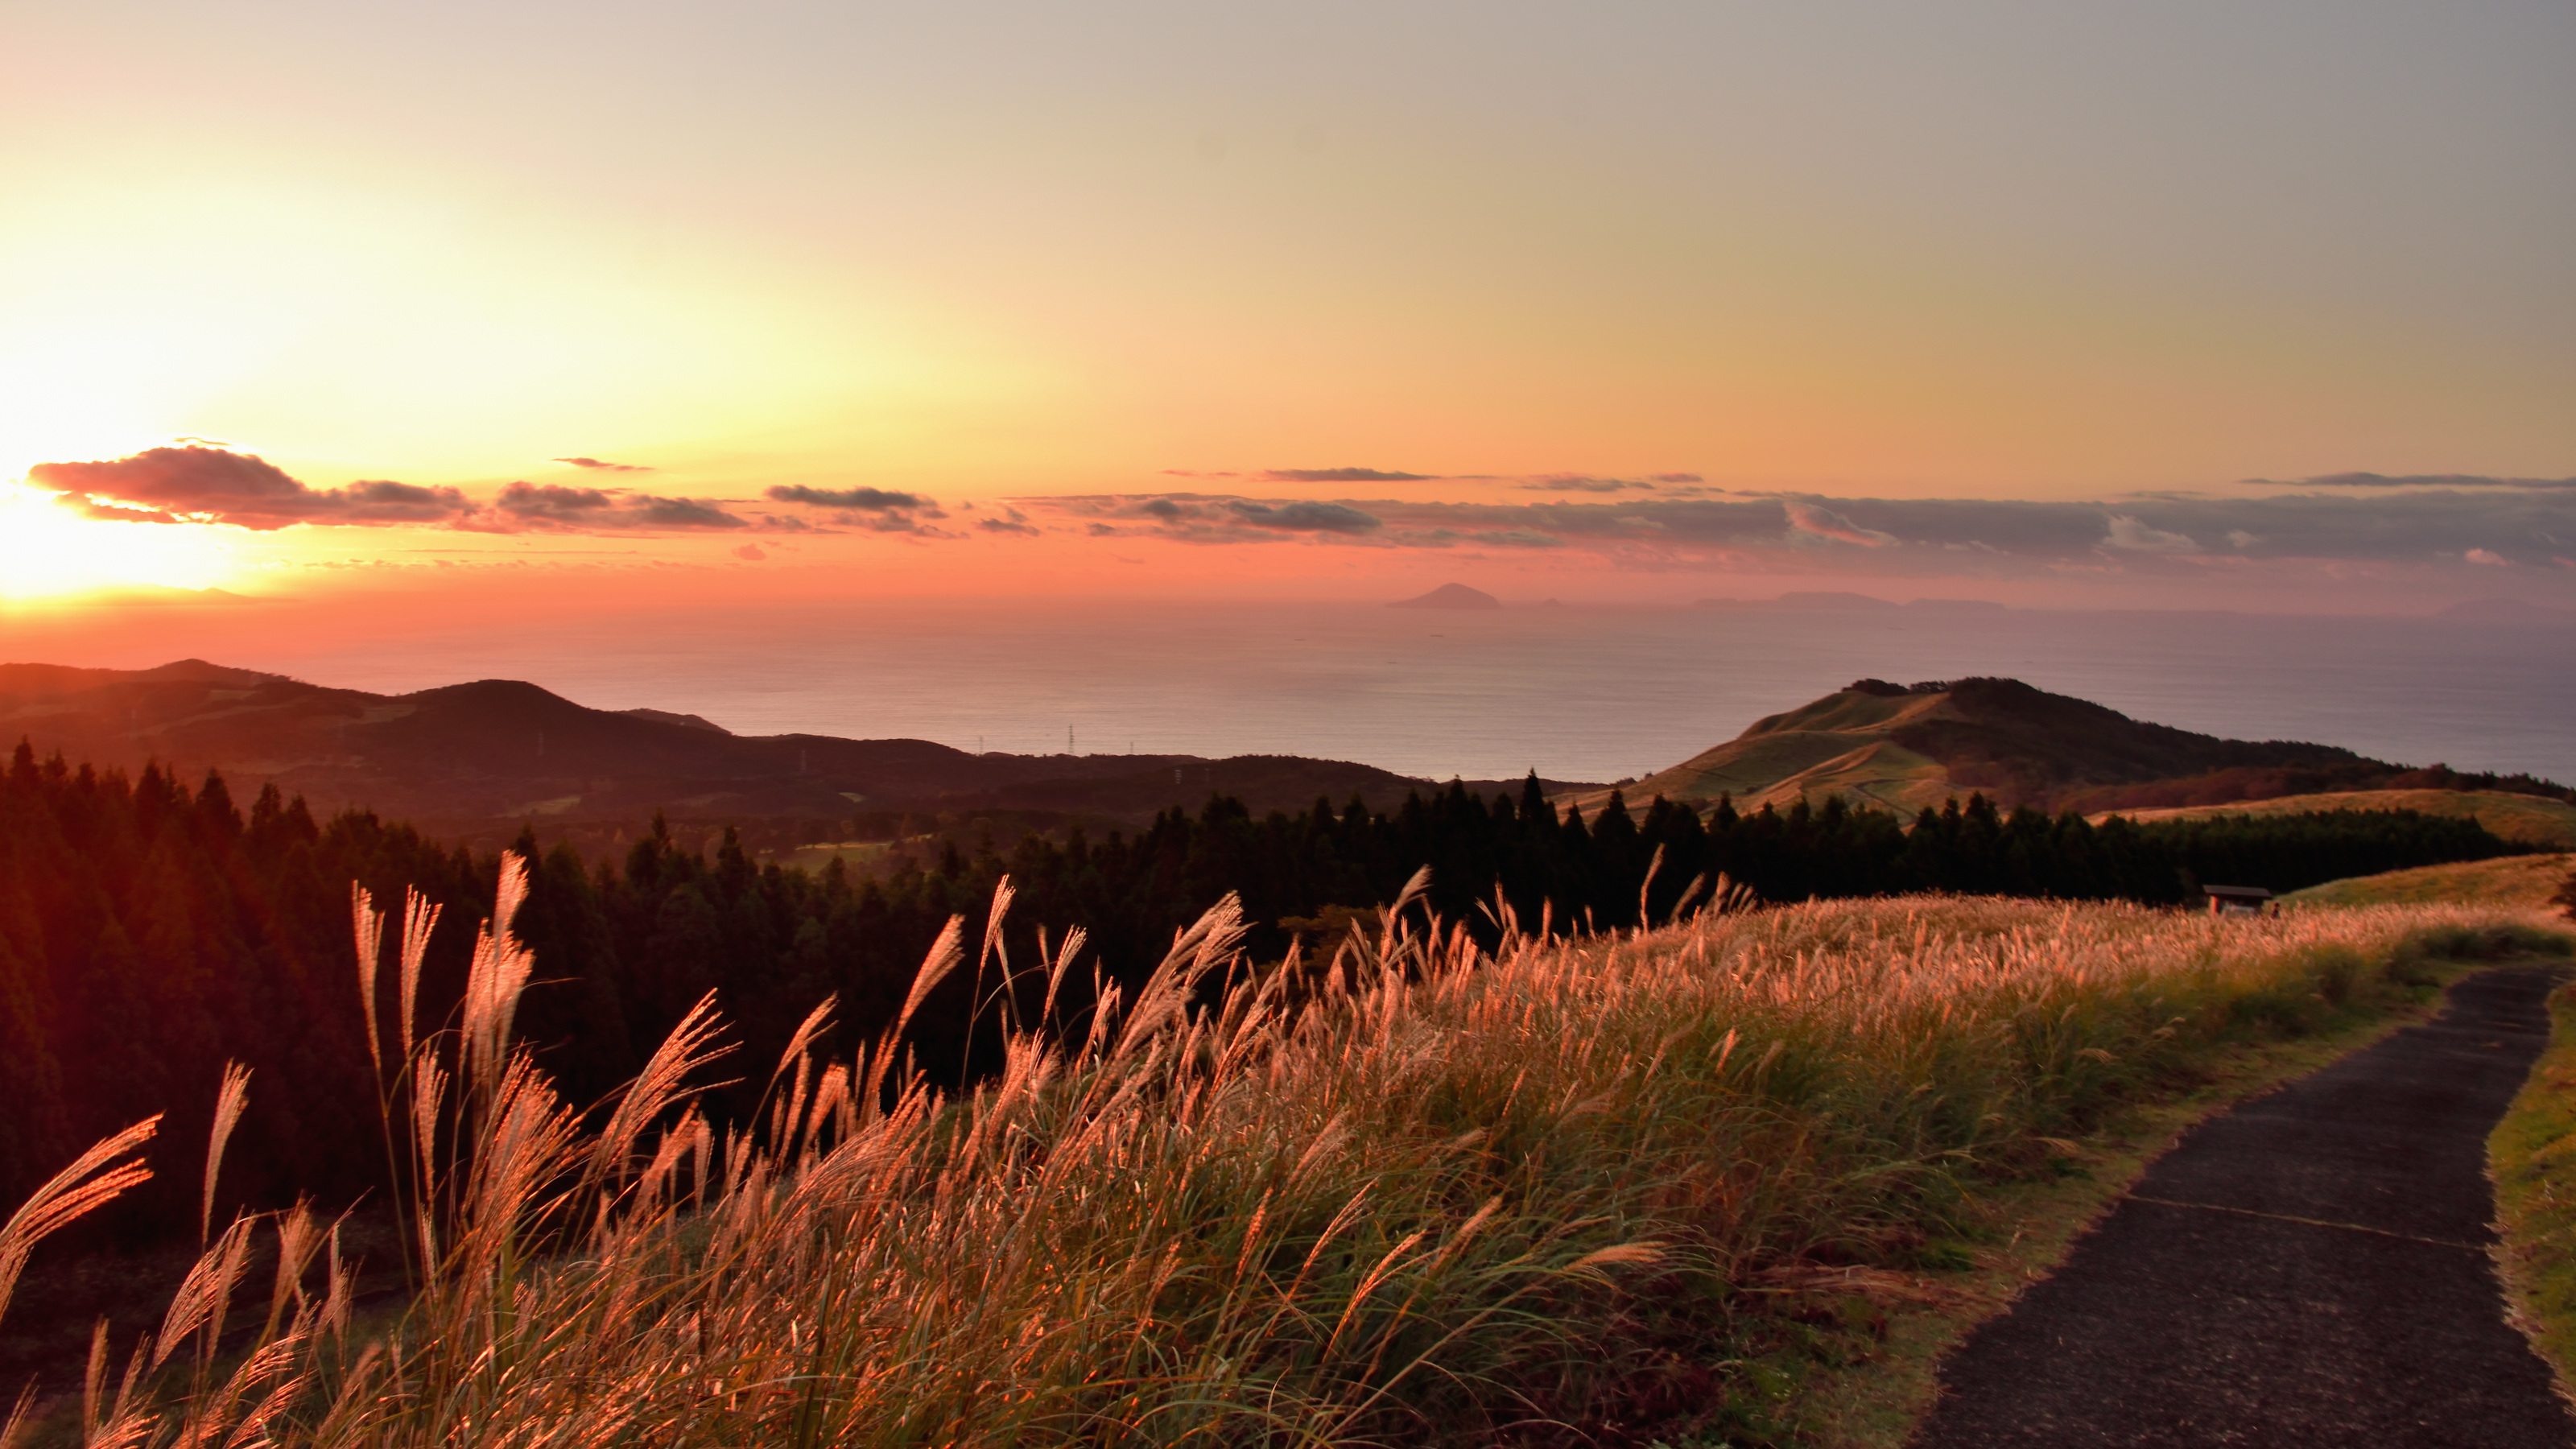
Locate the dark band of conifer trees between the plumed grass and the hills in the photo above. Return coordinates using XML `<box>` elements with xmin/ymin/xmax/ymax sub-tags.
<box><xmin>0</xmin><ymin>745</ymin><xmax>2507</xmax><ymax>1241</ymax></box>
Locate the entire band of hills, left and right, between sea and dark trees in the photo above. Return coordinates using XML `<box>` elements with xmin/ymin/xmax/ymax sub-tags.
<box><xmin>0</xmin><ymin>660</ymin><xmax>2576</xmax><ymax>856</ymax></box>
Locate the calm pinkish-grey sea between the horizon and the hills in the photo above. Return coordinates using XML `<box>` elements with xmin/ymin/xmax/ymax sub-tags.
<box><xmin>200</xmin><ymin>603</ymin><xmax>2576</xmax><ymax>781</ymax></box>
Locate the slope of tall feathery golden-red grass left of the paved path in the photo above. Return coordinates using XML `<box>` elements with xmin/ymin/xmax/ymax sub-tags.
<box><xmin>0</xmin><ymin>861</ymin><xmax>2555</xmax><ymax>1447</ymax></box>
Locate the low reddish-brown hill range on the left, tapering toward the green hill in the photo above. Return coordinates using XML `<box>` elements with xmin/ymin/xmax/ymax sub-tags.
<box><xmin>0</xmin><ymin>660</ymin><xmax>1569</xmax><ymax>843</ymax></box>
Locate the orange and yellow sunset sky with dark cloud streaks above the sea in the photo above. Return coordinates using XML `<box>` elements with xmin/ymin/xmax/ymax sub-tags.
<box><xmin>0</xmin><ymin>0</ymin><xmax>2576</xmax><ymax>611</ymax></box>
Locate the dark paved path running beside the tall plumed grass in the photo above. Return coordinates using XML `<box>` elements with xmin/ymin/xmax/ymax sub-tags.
<box><xmin>1914</xmin><ymin>967</ymin><xmax>2576</xmax><ymax>1449</ymax></box>
